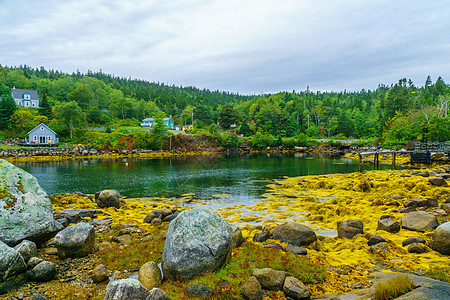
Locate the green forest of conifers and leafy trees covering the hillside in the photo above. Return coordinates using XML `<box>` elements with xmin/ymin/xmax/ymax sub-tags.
<box><xmin>0</xmin><ymin>65</ymin><xmax>450</xmax><ymax>146</ymax></box>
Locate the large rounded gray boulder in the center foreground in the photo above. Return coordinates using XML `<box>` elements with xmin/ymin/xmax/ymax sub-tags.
<box><xmin>162</xmin><ymin>208</ymin><xmax>233</xmax><ymax>280</ymax></box>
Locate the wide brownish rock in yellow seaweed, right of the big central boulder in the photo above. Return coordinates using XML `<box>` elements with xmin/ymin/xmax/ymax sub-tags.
<box><xmin>272</xmin><ymin>222</ymin><xmax>317</xmax><ymax>246</ymax></box>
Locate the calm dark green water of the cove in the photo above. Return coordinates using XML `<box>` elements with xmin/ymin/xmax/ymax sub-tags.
<box><xmin>15</xmin><ymin>153</ymin><xmax>390</xmax><ymax>202</ymax></box>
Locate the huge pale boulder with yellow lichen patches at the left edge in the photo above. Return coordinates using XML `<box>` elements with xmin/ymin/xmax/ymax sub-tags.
<box><xmin>0</xmin><ymin>159</ymin><xmax>62</xmax><ymax>246</ymax></box>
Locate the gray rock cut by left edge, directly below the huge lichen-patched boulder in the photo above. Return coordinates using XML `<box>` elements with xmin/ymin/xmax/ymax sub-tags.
<box><xmin>0</xmin><ymin>241</ymin><xmax>27</xmax><ymax>283</ymax></box>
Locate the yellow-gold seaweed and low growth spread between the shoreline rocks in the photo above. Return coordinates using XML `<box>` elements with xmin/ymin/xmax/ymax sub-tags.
<box><xmin>4</xmin><ymin>165</ymin><xmax>450</xmax><ymax>299</ymax></box>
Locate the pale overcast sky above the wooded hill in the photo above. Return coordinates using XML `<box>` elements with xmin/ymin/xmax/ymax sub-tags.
<box><xmin>0</xmin><ymin>0</ymin><xmax>450</xmax><ymax>94</ymax></box>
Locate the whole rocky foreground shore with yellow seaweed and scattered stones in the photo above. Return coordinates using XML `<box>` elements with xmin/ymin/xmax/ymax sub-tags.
<box><xmin>0</xmin><ymin>158</ymin><xmax>450</xmax><ymax>299</ymax></box>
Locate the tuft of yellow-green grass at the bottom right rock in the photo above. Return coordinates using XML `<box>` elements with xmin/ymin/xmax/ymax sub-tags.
<box><xmin>375</xmin><ymin>275</ymin><xmax>414</xmax><ymax>300</ymax></box>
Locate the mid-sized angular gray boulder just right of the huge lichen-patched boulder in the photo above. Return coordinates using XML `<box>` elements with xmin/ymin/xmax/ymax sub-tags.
<box><xmin>54</xmin><ymin>222</ymin><xmax>95</xmax><ymax>258</ymax></box>
